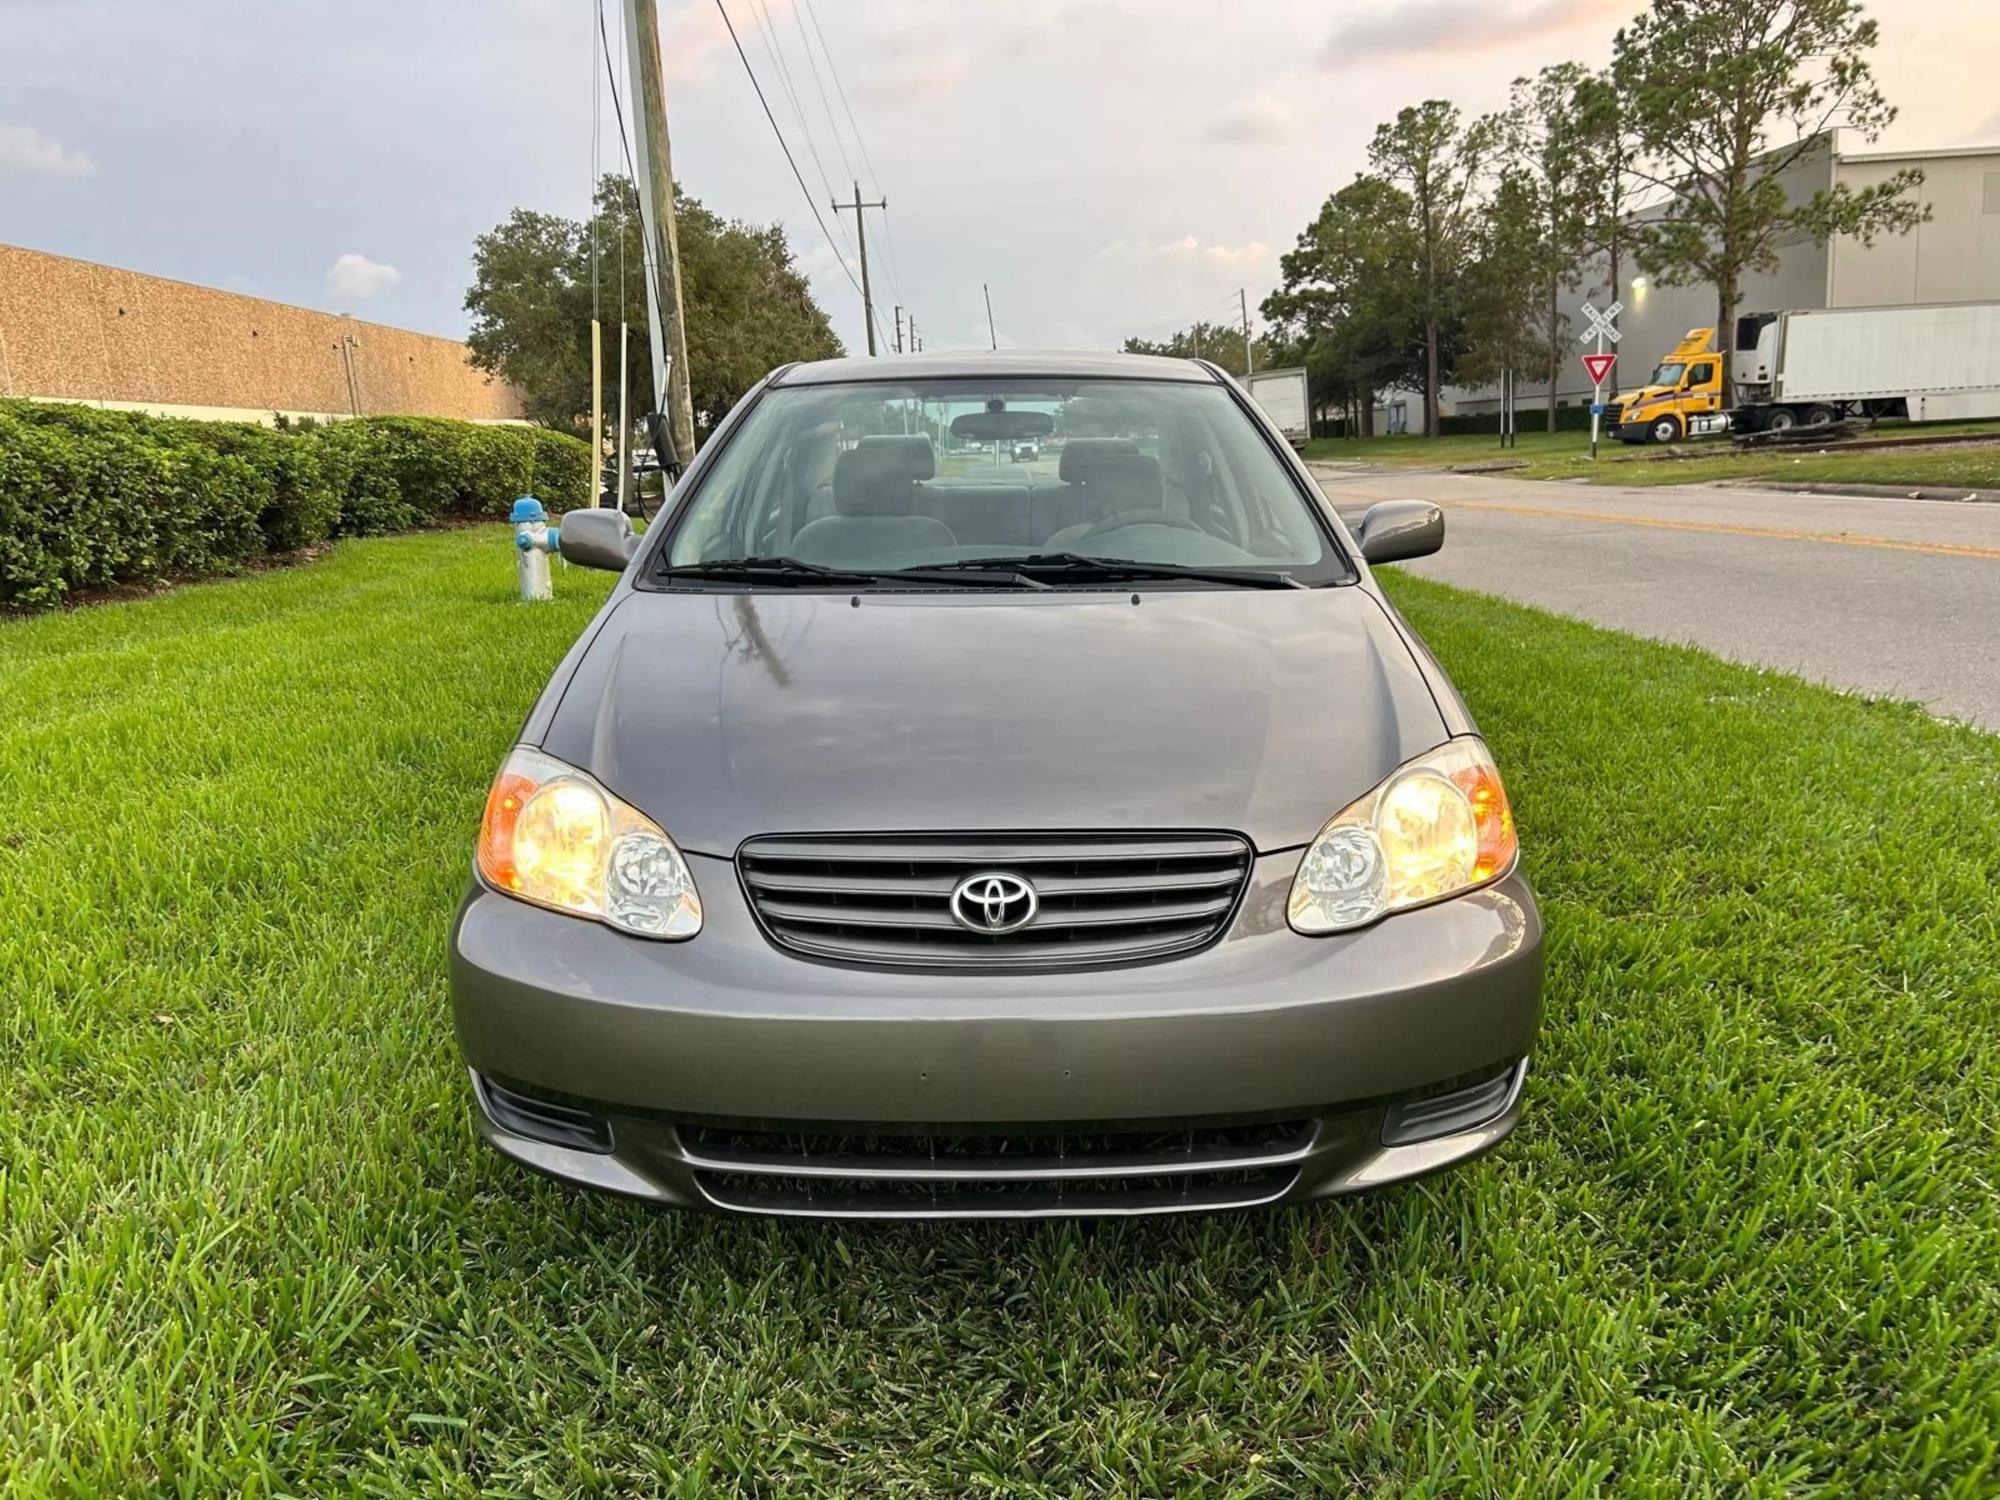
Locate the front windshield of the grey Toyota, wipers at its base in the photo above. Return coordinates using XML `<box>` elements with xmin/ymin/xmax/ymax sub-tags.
<box><xmin>648</xmin><ymin>378</ymin><xmax>1352</xmax><ymax>588</ymax></box>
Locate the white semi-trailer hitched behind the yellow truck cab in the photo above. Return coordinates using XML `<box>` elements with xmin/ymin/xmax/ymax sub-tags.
<box><xmin>1730</xmin><ymin>302</ymin><xmax>2000</xmax><ymax>432</ymax></box>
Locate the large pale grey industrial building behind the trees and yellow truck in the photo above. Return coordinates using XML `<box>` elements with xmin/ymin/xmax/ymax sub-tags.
<box><xmin>1424</xmin><ymin>132</ymin><xmax>2000</xmax><ymax>432</ymax></box>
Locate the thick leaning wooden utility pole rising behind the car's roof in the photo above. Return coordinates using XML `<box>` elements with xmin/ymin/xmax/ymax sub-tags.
<box><xmin>624</xmin><ymin>0</ymin><xmax>694</xmax><ymax>464</ymax></box>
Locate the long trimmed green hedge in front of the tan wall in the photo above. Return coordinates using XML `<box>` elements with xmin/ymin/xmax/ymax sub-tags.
<box><xmin>0</xmin><ymin>400</ymin><xmax>592</xmax><ymax>608</ymax></box>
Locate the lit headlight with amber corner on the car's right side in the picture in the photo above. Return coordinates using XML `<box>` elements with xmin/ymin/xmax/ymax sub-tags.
<box><xmin>1286</xmin><ymin>736</ymin><xmax>1518</xmax><ymax>936</ymax></box>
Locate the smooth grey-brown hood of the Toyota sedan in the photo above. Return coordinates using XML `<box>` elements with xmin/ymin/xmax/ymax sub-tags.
<box><xmin>542</xmin><ymin>586</ymin><xmax>1446</xmax><ymax>856</ymax></box>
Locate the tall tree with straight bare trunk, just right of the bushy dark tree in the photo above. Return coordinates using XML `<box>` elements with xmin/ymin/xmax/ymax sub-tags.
<box><xmin>1368</xmin><ymin>98</ymin><xmax>1496</xmax><ymax>438</ymax></box>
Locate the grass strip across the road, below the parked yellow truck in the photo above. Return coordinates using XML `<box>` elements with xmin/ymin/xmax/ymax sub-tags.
<box><xmin>1306</xmin><ymin>414</ymin><xmax>2000</xmax><ymax>488</ymax></box>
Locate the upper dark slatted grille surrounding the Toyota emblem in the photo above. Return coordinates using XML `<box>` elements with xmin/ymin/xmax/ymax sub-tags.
<box><xmin>736</xmin><ymin>834</ymin><xmax>1250</xmax><ymax>968</ymax></box>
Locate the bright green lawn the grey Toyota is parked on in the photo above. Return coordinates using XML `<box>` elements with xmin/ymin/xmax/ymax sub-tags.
<box><xmin>0</xmin><ymin>526</ymin><xmax>2000</xmax><ymax>1500</ymax></box>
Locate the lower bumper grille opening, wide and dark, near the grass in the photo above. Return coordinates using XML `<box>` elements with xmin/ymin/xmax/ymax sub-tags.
<box><xmin>680</xmin><ymin>1120</ymin><xmax>1316</xmax><ymax>1218</ymax></box>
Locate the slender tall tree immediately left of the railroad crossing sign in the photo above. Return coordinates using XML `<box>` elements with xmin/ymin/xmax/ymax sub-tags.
<box><xmin>1474</xmin><ymin>62</ymin><xmax>1616</xmax><ymax>432</ymax></box>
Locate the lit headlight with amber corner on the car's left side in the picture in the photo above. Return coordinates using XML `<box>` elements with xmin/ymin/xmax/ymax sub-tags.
<box><xmin>478</xmin><ymin>744</ymin><xmax>702</xmax><ymax>938</ymax></box>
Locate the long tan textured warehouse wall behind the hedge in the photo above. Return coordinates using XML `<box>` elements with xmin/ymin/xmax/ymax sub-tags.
<box><xmin>0</xmin><ymin>244</ymin><xmax>522</xmax><ymax>422</ymax></box>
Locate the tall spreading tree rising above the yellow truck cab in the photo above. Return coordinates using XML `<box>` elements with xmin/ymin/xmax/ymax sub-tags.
<box><xmin>1612</xmin><ymin>0</ymin><xmax>1926</xmax><ymax>390</ymax></box>
